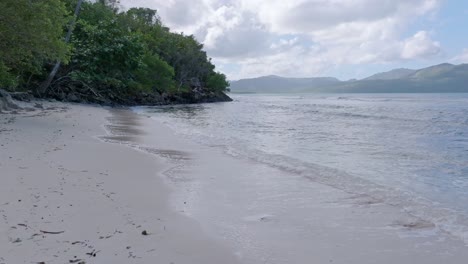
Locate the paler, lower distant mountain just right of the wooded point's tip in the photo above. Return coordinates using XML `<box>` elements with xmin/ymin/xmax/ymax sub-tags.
<box><xmin>230</xmin><ymin>75</ymin><xmax>340</xmax><ymax>93</ymax></box>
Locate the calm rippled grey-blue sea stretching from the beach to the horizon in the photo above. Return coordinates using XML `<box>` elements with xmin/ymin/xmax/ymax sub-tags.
<box><xmin>137</xmin><ymin>94</ymin><xmax>468</xmax><ymax>242</ymax></box>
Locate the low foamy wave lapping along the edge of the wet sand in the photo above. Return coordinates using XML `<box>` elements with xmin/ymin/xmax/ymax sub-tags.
<box><xmin>221</xmin><ymin>147</ymin><xmax>468</xmax><ymax>245</ymax></box>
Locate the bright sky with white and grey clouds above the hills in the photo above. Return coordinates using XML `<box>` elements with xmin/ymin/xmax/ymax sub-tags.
<box><xmin>121</xmin><ymin>0</ymin><xmax>468</xmax><ymax>80</ymax></box>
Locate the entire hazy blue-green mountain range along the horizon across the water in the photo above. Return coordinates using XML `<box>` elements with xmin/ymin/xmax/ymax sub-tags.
<box><xmin>231</xmin><ymin>63</ymin><xmax>468</xmax><ymax>93</ymax></box>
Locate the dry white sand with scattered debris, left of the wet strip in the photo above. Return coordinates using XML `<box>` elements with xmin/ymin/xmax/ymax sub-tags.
<box><xmin>0</xmin><ymin>103</ymin><xmax>236</xmax><ymax>264</ymax></box>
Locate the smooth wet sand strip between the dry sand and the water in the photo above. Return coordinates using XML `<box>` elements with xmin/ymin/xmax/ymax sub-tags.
<box><xmin>131</xmin><ymin>104</ymin><xmax>468</xmax><ymax>264</ymax></box>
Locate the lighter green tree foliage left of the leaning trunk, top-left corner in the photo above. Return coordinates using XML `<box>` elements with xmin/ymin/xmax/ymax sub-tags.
<box><xmin>0</xmin><ymin>0</ymin><xmax>69</xmax><ymax>87</ymax></box>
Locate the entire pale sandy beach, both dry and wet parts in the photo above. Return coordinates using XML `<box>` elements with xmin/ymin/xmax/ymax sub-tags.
<box><xmin>0</xmin><ymin>99</ymin><xmax>468</xmax><ymax>264</ymax></box>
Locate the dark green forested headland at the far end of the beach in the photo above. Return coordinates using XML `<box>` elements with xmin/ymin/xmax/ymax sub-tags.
<box><xmin>0</xmin><ymin>0</ymin><xmax>229</xmax><ymax>105</ymax></box>
